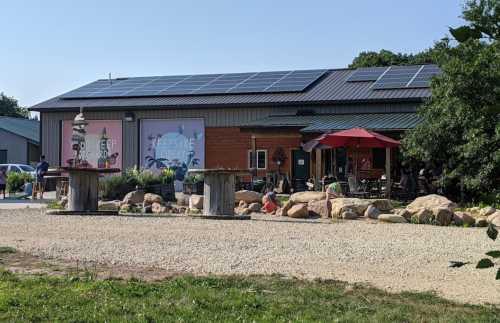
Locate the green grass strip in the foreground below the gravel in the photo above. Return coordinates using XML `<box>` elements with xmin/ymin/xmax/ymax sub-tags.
<box><xmin>0</xmin><ymin>271</ymin><xmax>500</xmax><ymax>322</ymax></box>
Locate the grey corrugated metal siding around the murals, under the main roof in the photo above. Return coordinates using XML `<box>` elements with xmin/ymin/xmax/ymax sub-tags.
<box><xmin>40</xmin><ymin>103</ymin><xmax>417</xmax><ymax>168</ymax></box>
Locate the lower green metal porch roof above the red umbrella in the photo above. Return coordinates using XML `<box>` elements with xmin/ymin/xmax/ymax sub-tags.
<box><xmin>243</xmin><ymin>113</ymin><xmax>420</xmax><ymax>132</ymax></box>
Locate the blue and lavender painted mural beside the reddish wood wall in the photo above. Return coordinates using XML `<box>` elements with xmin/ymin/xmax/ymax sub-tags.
<box><xmin>140</xmin><ymin>119</ymin><xmax>205</xmax><ymax>181</ymax></box>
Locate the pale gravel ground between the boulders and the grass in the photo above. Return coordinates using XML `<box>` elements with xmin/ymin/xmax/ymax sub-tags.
<box><xmin>0</xmin><ymin>210</ymin><xmax>500</xmax><ymax>304</ymax></box>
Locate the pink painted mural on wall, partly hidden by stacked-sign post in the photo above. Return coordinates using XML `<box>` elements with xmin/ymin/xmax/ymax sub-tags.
<box><xmin>61</xmin><ymin>120</ymin><xmax>122</xmax><ymax>168</ymax></box>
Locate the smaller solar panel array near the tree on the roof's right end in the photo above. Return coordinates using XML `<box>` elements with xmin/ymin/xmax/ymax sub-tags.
<box><xmin>372</xmin><ymin>65</ymin><xmax>440</xmax><ymax>90</ymax></box>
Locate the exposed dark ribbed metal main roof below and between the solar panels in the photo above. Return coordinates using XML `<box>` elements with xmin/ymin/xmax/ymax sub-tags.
<box><xmin>31</xmin><ymin>69</ymin><xmax>430</xmax><ymax>111</ymax></box>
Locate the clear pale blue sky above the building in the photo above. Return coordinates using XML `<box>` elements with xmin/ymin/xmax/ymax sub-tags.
<box><xmin>0</xmin><ymin>0</ymin><xmax>462</xmax><ymax>106</ymax></box>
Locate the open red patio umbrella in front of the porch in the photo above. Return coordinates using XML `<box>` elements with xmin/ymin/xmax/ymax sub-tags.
<box><xmin>316</xmin><ymin>128</ymin><xmax>399</xmax><ymax>191</ymax></box>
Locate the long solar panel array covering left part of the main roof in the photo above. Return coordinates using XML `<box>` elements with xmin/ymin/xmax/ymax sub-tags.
<box><xmin>62</xmin><ymin>70</ymin><xmax>326</xmax><ymax>99</ymax></box>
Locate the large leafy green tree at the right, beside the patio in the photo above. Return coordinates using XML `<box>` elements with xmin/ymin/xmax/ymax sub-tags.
<box><xmin>402</xmin><ymin>0</ymin><xmax>500</xmax><ymax>199</ymax></box>
